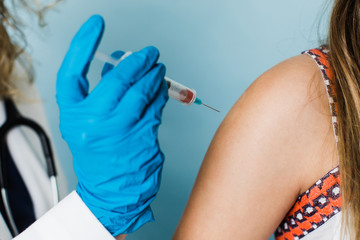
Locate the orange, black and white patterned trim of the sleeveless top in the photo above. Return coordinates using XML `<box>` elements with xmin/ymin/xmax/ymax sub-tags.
<box><xmin>275</xmin><ymin>48</ymin><xmax>341</xmax><ymax>240</ymax></box>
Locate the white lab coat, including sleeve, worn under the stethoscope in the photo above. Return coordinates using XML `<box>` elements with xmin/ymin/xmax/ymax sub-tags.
<box><xmin>0</xmin><ymin>81</ymin><xmax>114</xmax><ymax>240</ymax></box>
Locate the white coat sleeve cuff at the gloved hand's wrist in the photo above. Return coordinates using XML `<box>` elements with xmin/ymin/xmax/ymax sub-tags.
<box><xmin>14</xmin><ymin>191</ymin><xmax>114</xmax><ymax>240</ymax></box>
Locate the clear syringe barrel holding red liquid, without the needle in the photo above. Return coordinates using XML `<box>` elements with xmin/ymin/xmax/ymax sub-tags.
<box><xmin>165</xmin><ymin>77</ymin><xmax>196</xmax><ymax>105</ymax></box>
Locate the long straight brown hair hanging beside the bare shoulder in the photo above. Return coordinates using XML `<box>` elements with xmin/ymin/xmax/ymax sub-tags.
<box><xmin>328</xmin><ymin>0</ymin><xmax>360</xmax><ymax>239</ymax></box>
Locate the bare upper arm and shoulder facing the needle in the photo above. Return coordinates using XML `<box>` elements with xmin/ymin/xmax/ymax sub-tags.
<box><xmin>173</xmin><ymin>55</ymin><xmax>338</xmax><ymax>240</ymax></box>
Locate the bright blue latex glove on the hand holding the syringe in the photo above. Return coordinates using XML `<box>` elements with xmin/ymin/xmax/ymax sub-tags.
<box><xmin>57</xmin><ymin>16</ymin><xmax>168</xmax><ymax>236</ymax></box>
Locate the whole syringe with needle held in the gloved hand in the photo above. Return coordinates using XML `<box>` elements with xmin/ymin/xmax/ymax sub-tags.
<box><xmin>95</xmin><ymin>51</ymin><xmax>220</xmax><ymax>112</ymax></box>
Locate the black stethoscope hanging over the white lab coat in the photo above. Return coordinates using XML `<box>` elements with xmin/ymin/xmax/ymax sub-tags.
<box><xmin>0</xmin><ymin>99</ymin><xmax>59</xmax><ymax>236</ymax></box>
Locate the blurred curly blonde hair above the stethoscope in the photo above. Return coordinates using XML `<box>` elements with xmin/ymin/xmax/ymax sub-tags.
<box><xmin>0</xmin><ymin>0</ymin><xmax>62</xmax><ymax>97</ymax></box>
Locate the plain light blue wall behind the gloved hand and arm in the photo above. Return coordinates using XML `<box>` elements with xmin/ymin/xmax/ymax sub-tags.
<box><xmin>23</xmin><ymin>0</ymin><xmax>327</xmax><ymax>240</ymax></box>
